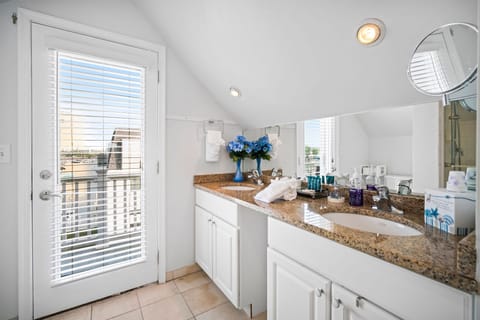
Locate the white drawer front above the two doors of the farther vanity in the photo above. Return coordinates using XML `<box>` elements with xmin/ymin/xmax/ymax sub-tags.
<box><xmin>195</xmin><ymin>189</ymin><xmax>238</xmax><ymax>227</ymax></box>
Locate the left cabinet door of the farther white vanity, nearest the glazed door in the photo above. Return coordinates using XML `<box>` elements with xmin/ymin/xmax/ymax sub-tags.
<box><xmin>195</xmin><ymin>206</ymin><xmax>212</xmax><ymax>278</ymax></box>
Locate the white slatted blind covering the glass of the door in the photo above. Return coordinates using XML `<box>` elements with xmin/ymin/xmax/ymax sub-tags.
<box><xmin>50</xmin><ymin>50</ymin><xmax>146</xmax><ymax>282</ymax></box>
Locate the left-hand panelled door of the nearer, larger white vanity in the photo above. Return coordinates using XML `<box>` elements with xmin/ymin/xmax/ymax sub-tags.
<box><xmin>267</xmin><ymin>248</ymin><xmax>330</xmax><ymax>320</ymax></box>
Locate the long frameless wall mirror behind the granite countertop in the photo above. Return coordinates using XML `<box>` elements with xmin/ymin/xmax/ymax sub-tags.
<box><xmin>245</xmin><ymin>101</ymin><xmax>476</xmax><ymax>193</ymax></box>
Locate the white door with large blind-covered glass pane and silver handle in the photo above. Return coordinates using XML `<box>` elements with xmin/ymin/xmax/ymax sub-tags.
<box><xmin>32</xmin><ymin>24</ymin><xmax>160</xmax><ymax>318</ymax></box>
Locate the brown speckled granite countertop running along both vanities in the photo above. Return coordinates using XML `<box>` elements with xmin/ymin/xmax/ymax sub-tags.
<box><xmin>194</xmin><ymin>178</ymin><xmax>480</xmax><ymax>293</ymax></box>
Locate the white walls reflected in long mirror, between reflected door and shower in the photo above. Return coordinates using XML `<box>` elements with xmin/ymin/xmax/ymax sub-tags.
<box><xmin>337</xmin><ymin>103</ymin><xmax>441</xmax><ymax>192</ymax></box>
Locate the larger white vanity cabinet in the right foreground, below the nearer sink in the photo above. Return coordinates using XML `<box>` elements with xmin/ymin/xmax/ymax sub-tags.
<box><xmin>267</xmin><ymin>218</ymin><xmax>473</xmax><ymax>320</ymax></box>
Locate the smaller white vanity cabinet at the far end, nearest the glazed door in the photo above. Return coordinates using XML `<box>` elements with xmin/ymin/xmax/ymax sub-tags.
<box><xmin>195</xmin><ymin>189</ymin><xmax>267</xmax><ymax>315</ymax></box>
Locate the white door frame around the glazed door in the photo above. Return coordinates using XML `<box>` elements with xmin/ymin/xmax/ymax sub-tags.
<box><xmin>17</xmin><ymin>8</ymin><xmax>166</xmax><ymax>319</ymax></box>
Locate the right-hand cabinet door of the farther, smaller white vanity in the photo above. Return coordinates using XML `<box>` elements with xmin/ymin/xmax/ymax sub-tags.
<box><xmin>212</xmin><ymin>217</ymin><xmax>238</xmax><ymax>307</ymax></box>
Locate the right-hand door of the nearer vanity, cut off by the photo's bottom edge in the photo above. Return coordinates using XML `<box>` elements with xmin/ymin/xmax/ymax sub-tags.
<box><xmin>332</xmin><ymin>283</ymin><xmax>400</xmax><ymax>320</ymax></box>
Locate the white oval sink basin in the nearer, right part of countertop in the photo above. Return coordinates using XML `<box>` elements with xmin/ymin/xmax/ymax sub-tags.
<box><xmin>322</xmin><ymin>212</ymin><xmax>422</xmax><ymax>236</ymax></box>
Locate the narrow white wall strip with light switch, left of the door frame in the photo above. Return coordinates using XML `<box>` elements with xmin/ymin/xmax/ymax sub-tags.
<box><xmin>0</xmin><ymin>2</ymin><xmax>17</xmax><ymax>319</ymax></box>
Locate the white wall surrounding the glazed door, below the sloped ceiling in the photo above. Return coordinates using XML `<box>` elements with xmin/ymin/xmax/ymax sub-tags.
<box><xmin>0</xmin><ymin>0</ymin><xmax>241</xmax><ymax>319</ymax></box>
